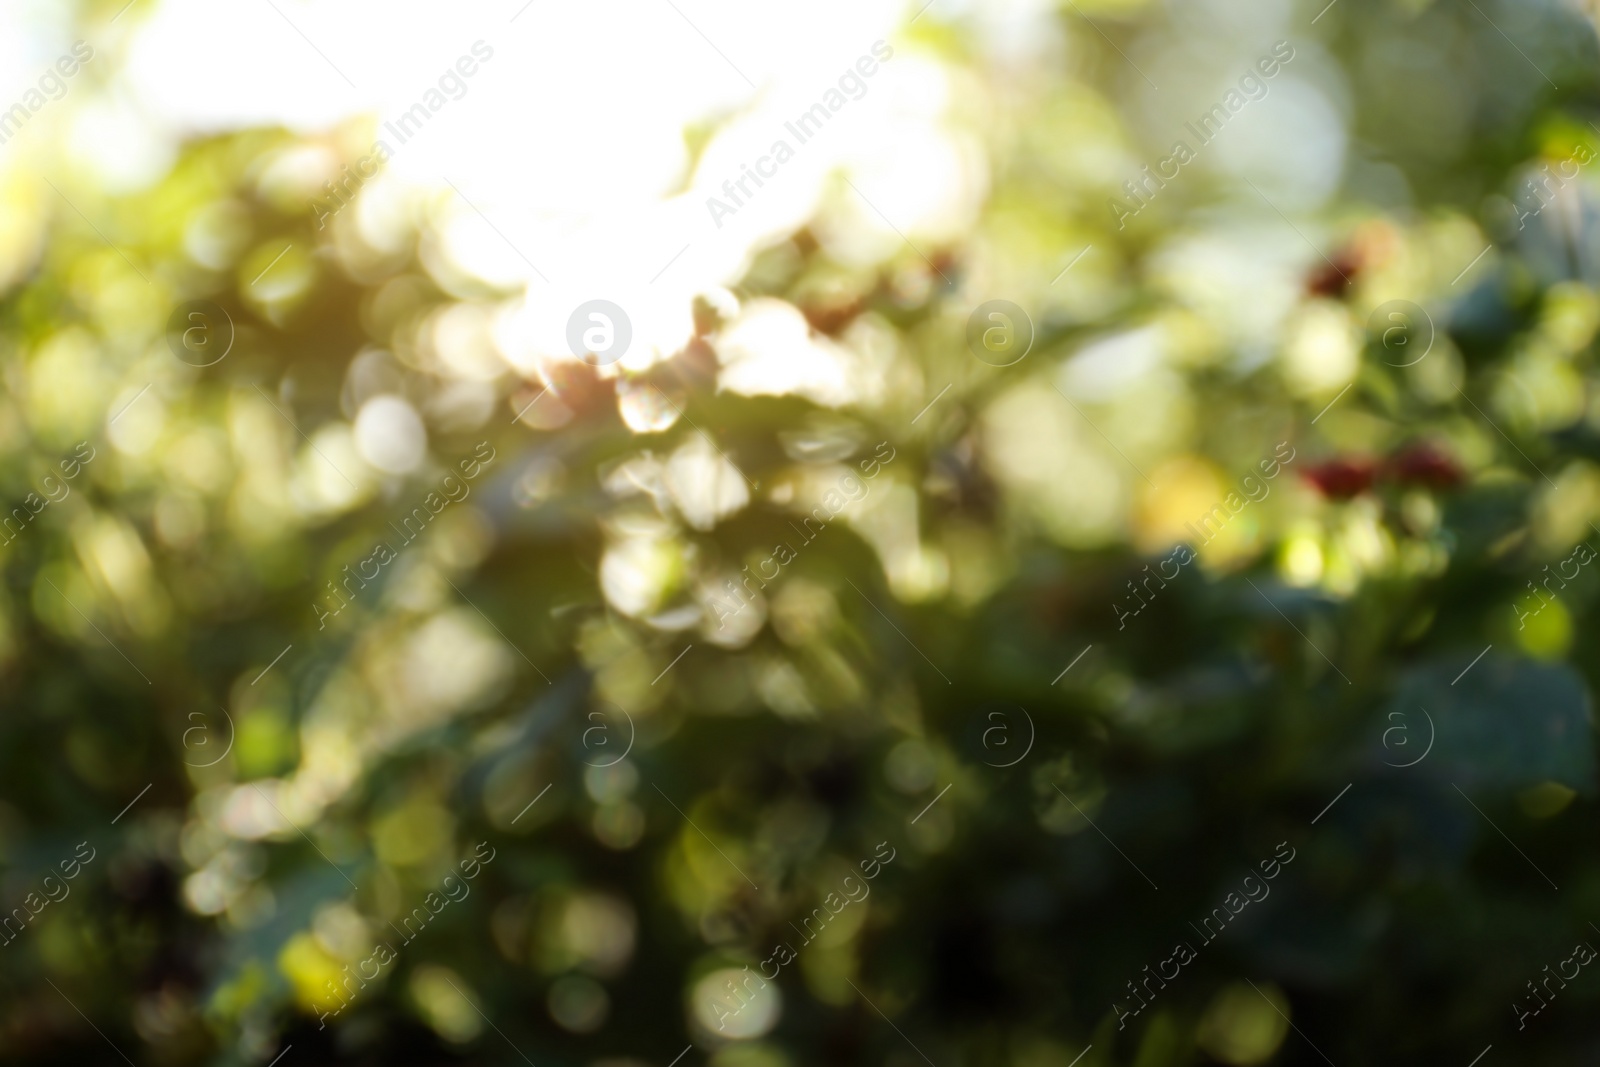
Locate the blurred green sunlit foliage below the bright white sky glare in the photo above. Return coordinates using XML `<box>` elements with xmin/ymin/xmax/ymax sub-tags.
<box><xmin>0</xmin><ymin>0</ymin><xmax>1600</xmax><ymax>1067</ymax></box>
